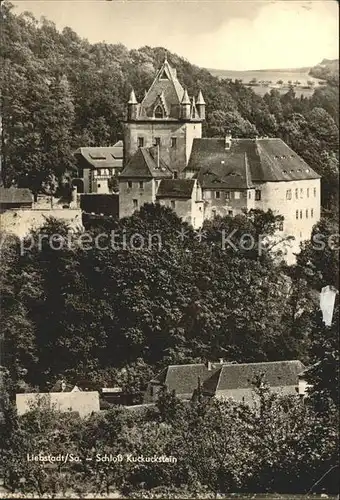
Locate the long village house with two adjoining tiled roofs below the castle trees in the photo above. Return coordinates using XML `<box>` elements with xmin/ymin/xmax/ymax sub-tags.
<box><xmin>144</xmin><ymin>360</ymin><xmax>305</xmax><ymax>404</ymax></box>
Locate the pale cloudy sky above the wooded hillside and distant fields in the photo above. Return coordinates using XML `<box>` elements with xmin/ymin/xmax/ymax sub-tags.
<box><xmin>11</xmin><ymin>0</ymin><xmax>339</xmax><ymax>71</ymax></box>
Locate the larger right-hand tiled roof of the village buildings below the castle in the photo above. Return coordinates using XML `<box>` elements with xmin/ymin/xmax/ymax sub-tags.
<box><xmin>203</xmin><ymin>360</ymin><xmax>305</xmax><ymax>394</ymax></box>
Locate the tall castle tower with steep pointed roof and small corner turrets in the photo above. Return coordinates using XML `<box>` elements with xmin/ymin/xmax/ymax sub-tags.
<box><xmin>124</xmin><ymin>59</ymin><xmax>204</xmax><ymax>176</ymax></box>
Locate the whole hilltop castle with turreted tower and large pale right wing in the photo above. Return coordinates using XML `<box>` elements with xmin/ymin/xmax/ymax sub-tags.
<box><xmin>119</xmin><ymin>60</ymin><xmax>320</xmax><ymax>254</ymax></box>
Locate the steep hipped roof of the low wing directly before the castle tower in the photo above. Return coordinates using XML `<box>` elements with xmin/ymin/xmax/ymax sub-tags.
<box><xmin>119</xmin><ymin>146</ymin><xmax>172</xmax><ymax>179</ymax></box>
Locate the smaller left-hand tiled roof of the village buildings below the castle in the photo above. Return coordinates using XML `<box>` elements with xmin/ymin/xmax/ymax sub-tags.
<box><xmin>151</xmin><ymin>363</ymin><xmax>220</xmax><ymax>397</ymax></box>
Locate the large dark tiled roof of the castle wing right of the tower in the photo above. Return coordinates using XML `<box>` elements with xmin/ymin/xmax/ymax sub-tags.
<box><xmin>186</xmin><ymin>138</ymin><xmax>320</xmax><ymax>189</ymax></box>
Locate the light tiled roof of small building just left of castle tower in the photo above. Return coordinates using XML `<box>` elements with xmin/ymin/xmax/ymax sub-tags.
<box><xmin>75</xmin><ymin>145</ymin><xmax>123</xmax><ymax>168</ymax></box>
